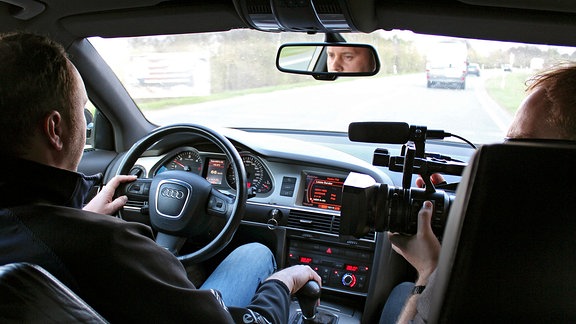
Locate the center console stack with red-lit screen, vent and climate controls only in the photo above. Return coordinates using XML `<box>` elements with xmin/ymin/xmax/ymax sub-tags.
<box><xmin>286</xmin><ymin>171</ymin><xmax>374</xmax><ymax>296</ymax></box>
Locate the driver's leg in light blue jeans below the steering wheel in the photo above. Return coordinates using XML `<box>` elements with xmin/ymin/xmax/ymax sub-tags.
<box><xmin>200</xmin><ymin>243</ymin><xmax>276</xmax><ymax>307</ymax></box>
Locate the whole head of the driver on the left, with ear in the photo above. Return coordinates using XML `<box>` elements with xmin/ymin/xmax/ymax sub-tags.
<box><xmin>0</xmin><ymin>33</ymin><xmax>87</xmax><ymax>171</ymax></box>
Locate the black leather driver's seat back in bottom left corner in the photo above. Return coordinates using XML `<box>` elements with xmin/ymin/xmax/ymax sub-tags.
<box><xmin>0</xmin><ymin>263</ymin><xmax>107</xmax><ymax>323</ymax></box>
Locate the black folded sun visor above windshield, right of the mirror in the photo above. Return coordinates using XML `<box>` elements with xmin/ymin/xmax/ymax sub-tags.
<box><xmin>378</xmin><ymin>1</ymin><xmax>576</xmax><ymax>46</ymax></box>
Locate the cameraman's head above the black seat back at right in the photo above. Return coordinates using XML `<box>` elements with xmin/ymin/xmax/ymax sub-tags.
<box><xmin>507</xmin><ymin>63</ymin><xmax>576</xmax><ymax>140</ymax></box>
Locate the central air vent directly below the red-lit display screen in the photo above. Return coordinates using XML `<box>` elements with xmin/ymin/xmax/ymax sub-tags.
<box><xmin>288</xmin><ymin>210</ymin><xmax>375</xmax><ymax>241</ymax></box>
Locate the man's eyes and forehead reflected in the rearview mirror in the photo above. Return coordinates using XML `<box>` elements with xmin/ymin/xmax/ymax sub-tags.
<box><xmin>327</xmin><ymin>46</ymin><xmax>376</xmax><ymax>73</ymax></box>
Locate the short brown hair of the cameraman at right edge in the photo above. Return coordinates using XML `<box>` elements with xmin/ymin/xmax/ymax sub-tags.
<box><xmin>527</xmin><ymin>62</ymin><xmax>576</xmax><ymax>140</ymax></box>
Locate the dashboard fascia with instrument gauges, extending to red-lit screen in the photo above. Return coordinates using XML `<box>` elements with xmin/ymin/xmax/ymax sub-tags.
<box><xmin>128</xmin><ymin>142</ymin><xmax>358</xmax><ymax>224</ymax></box>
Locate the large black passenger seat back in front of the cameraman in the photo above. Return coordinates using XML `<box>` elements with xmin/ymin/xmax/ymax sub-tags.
<box><xmin>430</xmin><ymin>142</ymin><xmax>576</xmax><ymax>323</ymax></box>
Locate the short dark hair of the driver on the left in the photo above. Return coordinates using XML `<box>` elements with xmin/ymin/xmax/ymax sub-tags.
<box><xmin>0</xmin><ymin>32</ymin><xmax>75</xmax><ymax>156</ymax></box>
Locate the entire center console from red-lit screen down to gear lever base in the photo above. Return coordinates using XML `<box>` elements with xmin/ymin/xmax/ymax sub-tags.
<box><xmin>240</xmin><ymin>170</ymin><xmax>376</xmax><ymax>324</ymax></box>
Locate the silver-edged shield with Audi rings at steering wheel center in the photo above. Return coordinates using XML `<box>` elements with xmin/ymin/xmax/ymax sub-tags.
<box><xmin>156</xmin><ymin>181</ymin><xmax>190</xmax><ymax>218</ymax></box>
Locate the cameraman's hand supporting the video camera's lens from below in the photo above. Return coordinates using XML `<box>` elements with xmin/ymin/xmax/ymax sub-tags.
<box><xmin>388</xmin><ymin>201</ymin><xmax>440</xmax><ymax>285</ymax></box>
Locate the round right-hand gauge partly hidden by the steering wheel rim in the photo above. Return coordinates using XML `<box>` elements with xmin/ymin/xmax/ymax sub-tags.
<box><xmin>226</xmin><ymin>154</ymin><xmax>272</xmax><ymax>193</ymax></box>
